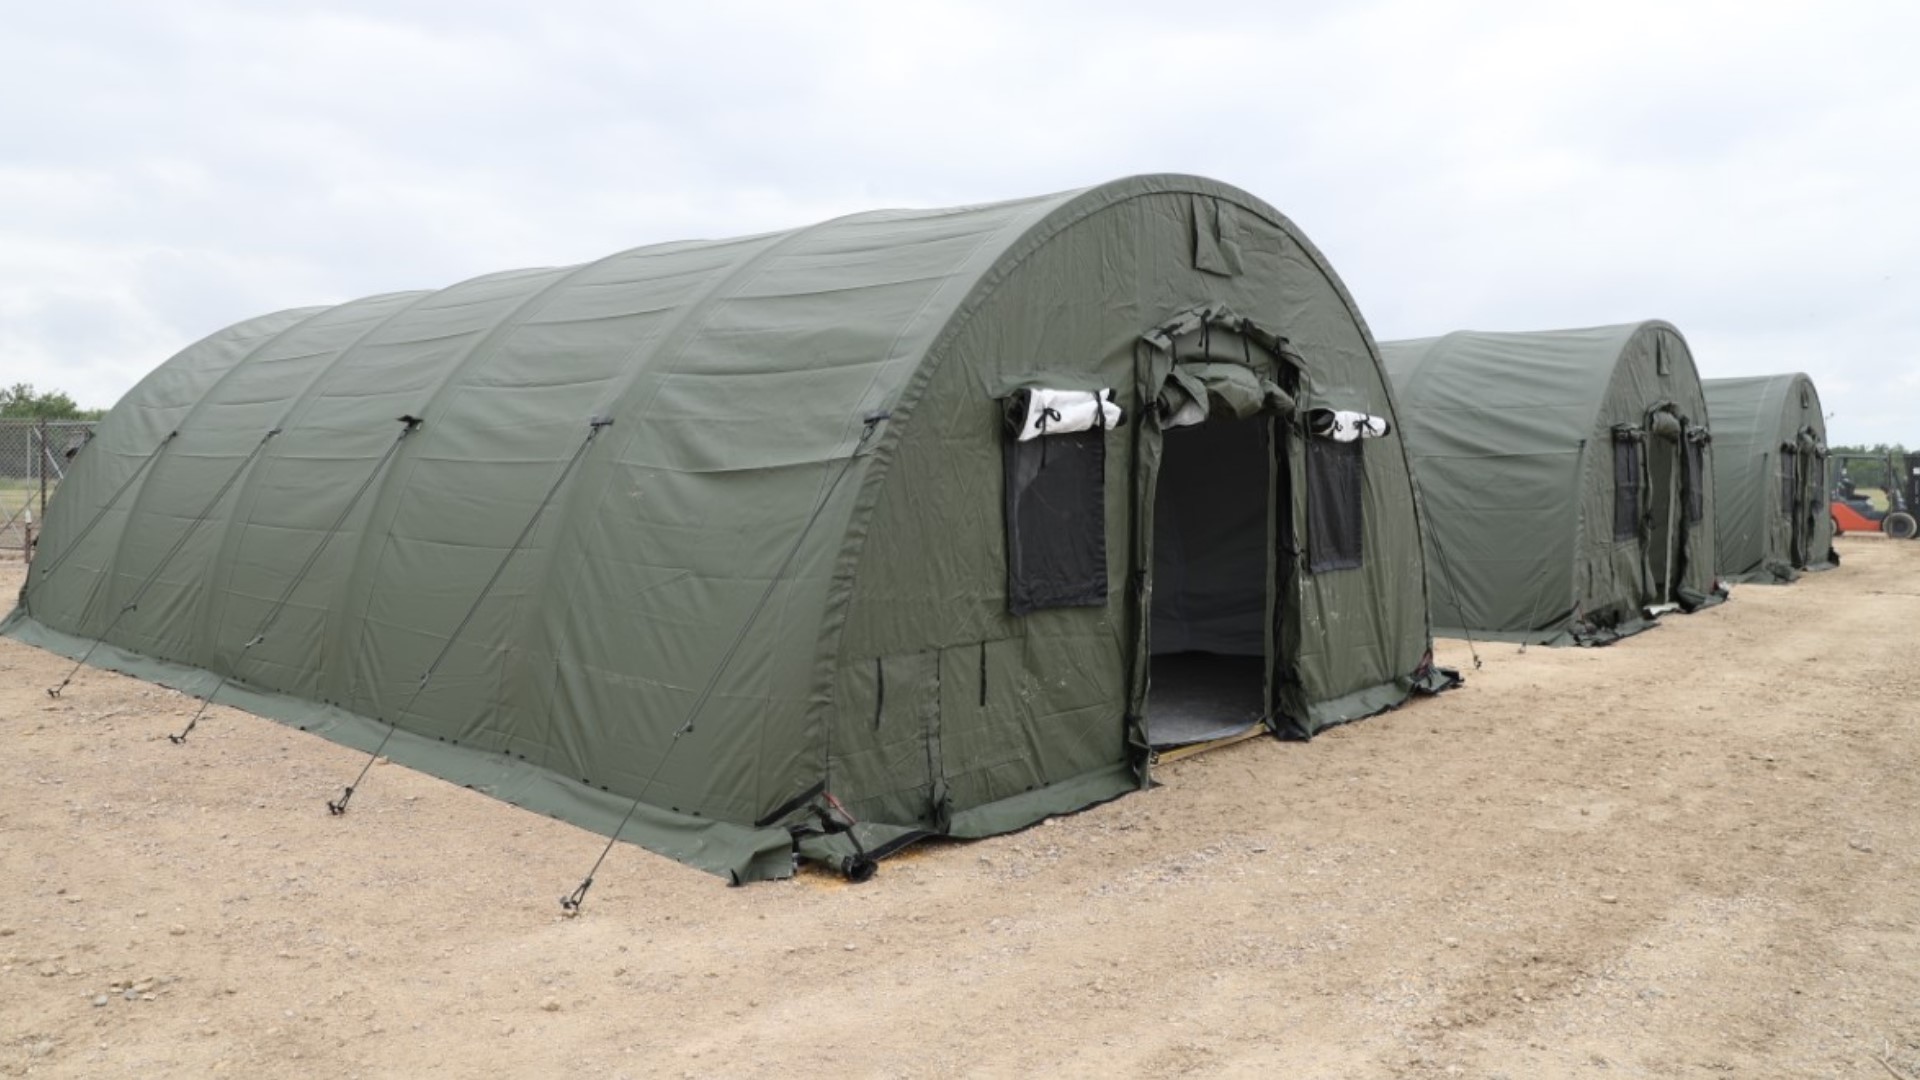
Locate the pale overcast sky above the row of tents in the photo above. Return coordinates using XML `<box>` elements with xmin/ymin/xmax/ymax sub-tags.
<box><xmin>0</xmin><ymin>0</ymin><xmax>1920</xmax><ymax>446</ymax></box>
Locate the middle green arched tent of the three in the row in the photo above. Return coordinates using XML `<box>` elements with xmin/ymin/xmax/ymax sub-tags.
<box><xmin>1380</xmin><ymin>321</ymin><xmax>1726</xmax><ymax>644</ymax></box>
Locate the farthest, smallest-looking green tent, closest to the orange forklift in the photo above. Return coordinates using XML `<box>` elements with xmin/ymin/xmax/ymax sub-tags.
<box><xmin>1701</xmin><ymin>375</ymin><xmax>1839</xmax><ymax>582</ymax></box>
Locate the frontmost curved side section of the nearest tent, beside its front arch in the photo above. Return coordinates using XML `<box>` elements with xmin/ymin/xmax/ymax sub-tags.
<box><xmin>524</xmin><ymin>191</ymin><xmax>1052</xmax><ymax>819</ymax></box>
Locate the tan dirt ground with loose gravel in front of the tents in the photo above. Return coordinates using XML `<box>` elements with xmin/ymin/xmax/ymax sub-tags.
<box><xmin>0</xmin><ymin>538</ymin><xmax>1920</xmax><ymax>1080</ymax></box>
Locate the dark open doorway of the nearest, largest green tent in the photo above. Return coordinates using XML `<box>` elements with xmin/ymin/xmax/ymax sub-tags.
<box><xmin>1146</xmin><ymin>417</ymin><xmax>1275</xmax><ymax>749</ymax></box>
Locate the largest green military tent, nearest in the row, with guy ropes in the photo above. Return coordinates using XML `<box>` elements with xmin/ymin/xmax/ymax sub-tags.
<box><xmin>6</xmin><ymin>175</ymin><xmax>1448</xmax><ymax>880</ymax></box>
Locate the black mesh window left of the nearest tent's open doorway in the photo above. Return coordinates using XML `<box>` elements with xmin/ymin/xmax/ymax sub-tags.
<box><xmin>1004</xmin><ymin>429</ymin><xmax>1106</xmax><ymax>615</ymax></box>
